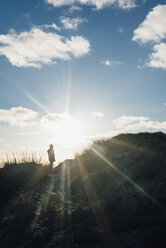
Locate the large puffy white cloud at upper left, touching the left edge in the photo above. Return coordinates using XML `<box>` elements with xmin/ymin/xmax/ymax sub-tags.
<box><xmin>0</xmin><ymin>28</ymin><xmax>90</xmax><ymax>68</ymax></box>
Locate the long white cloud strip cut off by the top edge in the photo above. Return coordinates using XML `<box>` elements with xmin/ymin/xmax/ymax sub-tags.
<box><xmin>45</xmin><ymin>0</ymin><xmax>136</xmax><ymax>9</ymax></box>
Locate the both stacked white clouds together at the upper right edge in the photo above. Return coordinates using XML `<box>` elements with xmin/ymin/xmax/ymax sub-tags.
<box><xmin>132</xmin><ymin>5</ymin><xmax>166</xmax><ymax>69</ymax></box>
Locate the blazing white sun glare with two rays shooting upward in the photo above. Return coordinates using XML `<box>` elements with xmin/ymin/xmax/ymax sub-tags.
<box><xmin>20</xmin><ymin>84</ymin><xmax>86</xmax><ymax>162</ymax></box>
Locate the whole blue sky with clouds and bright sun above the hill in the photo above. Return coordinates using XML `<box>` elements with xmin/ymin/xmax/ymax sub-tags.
<box><xmin>0</xmin><ymin>0</ymin><xmax>166</xmax><ymax>163</ymax></box>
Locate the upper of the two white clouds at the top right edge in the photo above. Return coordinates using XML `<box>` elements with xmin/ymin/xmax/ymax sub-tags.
<box><xmin>133</xmin><ymin>5</ymin><xmax>166</xmax><ymax>43</ymax></box>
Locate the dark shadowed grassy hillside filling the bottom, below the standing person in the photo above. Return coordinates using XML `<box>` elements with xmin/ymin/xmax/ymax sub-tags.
<box><xmin>0</xmin><ymin>132</ymin><xmax>166</xmax><ymax>248</ymax></box>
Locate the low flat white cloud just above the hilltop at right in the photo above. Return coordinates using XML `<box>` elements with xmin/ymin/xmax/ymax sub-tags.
<box><xmin>113</xmin><ymin>116</ymin><xmax>166</xmax><ymax>131</ymax></box>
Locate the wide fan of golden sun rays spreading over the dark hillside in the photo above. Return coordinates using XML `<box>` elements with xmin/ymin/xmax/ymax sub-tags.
<box><xmin>28</xmin><ymin>134</ymin><xmax>166</xmax><ymax>242</ymax></box>
